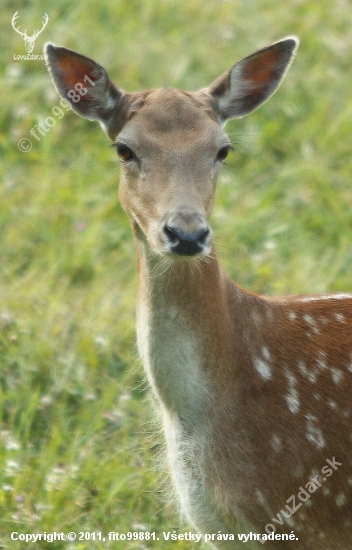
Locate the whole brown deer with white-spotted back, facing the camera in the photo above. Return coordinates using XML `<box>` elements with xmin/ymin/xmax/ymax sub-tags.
<box><xmin>45</xmin><ymin>36</ymin><xmax>352</xmax><ymax>550</ymax></box>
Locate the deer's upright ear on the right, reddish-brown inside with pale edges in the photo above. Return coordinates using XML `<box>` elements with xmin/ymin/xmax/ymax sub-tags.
<box><xmin>204</xmin><ymin>37</ymin><xmax>299</xmax><ymax>125</ymax></box>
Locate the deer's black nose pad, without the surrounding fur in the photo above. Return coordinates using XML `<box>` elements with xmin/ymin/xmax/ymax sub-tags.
<box><xmin>164</xmin><ymin>224</ymin><xmax>210</xmax><ymax>256</ymax></box>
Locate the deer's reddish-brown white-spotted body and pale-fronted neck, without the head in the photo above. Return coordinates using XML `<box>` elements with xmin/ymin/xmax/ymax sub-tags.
<box><xmin>137</xmin><ymin>245</ymin><xmax>352</xmax><ymax>550</ymax></box>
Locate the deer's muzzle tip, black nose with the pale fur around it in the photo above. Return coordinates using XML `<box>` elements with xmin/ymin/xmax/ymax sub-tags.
<box><xmin>163</xmin><ymin>210</ymin><xmax>211</xmax><ymax>256</ymax></box>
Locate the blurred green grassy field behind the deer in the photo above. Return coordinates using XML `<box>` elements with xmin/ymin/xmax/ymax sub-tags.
<box><xmin>0</xmin><ymin>0</ymin><xmax>352</xmax><ymax>550</ymax></box>
